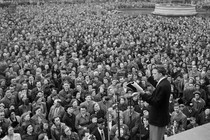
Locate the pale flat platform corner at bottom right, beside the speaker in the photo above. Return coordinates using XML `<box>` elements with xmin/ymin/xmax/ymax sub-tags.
<box><xmin>165</xmin><ymin>123</ymin><xmax>210</xmax><ymax>140</ymax></box>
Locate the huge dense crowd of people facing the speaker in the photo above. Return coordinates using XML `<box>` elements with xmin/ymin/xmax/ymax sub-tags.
<box><xmin>0</xmin><ymin>3</ymin><xmax>210</xmax><ymax>140</ymax></box>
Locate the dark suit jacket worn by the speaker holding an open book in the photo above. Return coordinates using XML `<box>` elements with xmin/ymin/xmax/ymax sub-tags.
<box><xmin>141</xmin><ymin>78</ymin><xmax>171</xmax><ymax>127</ymax></box>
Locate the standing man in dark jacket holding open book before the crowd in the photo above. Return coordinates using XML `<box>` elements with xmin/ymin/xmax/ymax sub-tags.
<box><xmin>132</xmin><ymin>66</ymin><xmax>171</xmax><ymax>140</ymax></box>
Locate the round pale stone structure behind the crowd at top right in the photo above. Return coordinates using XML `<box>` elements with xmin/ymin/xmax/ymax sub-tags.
<box><xmin>152</xmin><ymin>4</ymin><xmax>197</xmax><ymax>16</ymax></box>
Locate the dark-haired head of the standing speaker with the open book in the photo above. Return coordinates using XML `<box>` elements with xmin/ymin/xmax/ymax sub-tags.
<box><xmin>152</xmin><ymin>66</ymin><xmax>166</xmax><ymax>81</ymax></box>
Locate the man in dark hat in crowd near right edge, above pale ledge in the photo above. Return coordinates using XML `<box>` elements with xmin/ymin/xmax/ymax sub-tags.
<box><xmin>192</xmin><ymin>91</ymin><xmax>206</xmax><ymax>113</ymax></box>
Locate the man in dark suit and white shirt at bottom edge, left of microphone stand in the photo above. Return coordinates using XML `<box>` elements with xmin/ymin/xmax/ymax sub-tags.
<box><xmin>93</xmin><ymin>118</ymin><xmax>108</xmax><ymax>140</ymax></box>
